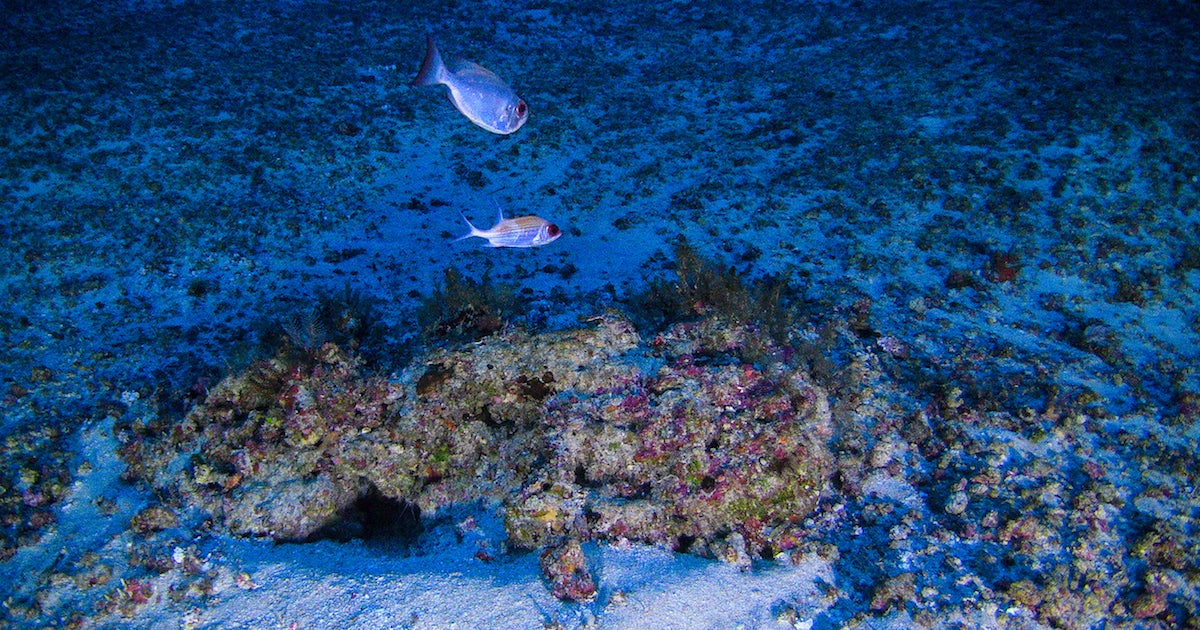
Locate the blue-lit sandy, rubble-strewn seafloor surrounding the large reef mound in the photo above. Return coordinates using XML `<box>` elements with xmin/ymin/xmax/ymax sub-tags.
<box><xmin>0</xmin><ymin>0</ymin><xmax>1200</xmax><ymax>628</ymax></box>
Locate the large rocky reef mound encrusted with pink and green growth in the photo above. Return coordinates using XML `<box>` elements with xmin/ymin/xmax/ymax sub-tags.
<box><xmin>125</xmin><ymin>313</ymin><xmax>832</xmax><ymax>599</ymax></box>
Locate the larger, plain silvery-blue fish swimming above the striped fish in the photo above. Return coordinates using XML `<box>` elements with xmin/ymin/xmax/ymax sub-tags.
<box><xmin>413</xmin><ymin>35</ymin><xmax>529</xmax><ymax>136</ymax></box>
